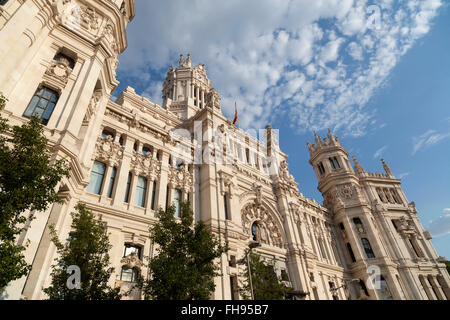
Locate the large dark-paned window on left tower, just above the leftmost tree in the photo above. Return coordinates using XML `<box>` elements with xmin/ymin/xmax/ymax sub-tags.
<box><xmin>23</xmin><ymin>87</ymin><xmax>59</xmax><ymax>126</ymax></box>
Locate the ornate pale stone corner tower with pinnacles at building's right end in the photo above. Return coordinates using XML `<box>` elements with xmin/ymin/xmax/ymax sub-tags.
<box><xmin>307</xmin><ymin>131</ymin><xmax>450</xmax><ymax>299</ymax></box>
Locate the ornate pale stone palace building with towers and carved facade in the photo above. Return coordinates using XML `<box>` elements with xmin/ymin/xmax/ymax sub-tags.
<box><xmin>0</xmin><ymin>0</ymin><xmax>450</xmax><ymax>300</ymax></box>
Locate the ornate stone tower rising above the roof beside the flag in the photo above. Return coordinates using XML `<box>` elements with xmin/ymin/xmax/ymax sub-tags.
<box><xmin>162</xmin><ymin>53</ymin><xmax>220</xmax><ymax>120</ymax></box>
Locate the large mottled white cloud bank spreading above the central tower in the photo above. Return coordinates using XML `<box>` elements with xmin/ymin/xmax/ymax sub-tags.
<box><xmin>119</xmin><ymin>0</ymin><xmax>442</xmax><ymax>136</ymax></box>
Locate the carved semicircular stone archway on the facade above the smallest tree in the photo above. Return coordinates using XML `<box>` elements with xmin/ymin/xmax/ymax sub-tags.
<box><xmin>241</xmin><ymin>203</ymin><xmax>284</xmax><ymax>248</ymax></box>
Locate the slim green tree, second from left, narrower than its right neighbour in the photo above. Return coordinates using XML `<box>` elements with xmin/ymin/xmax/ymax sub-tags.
<box><xmin>44</xmin><ymin>204</ymin><xmax>122</xmax><ymax>300</ymax></box>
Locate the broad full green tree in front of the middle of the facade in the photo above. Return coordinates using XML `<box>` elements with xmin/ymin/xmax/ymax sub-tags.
<box><xmin>141</xmin><ymin>202</ymin><xmax>228</xmax><ymax>300</ymax></box>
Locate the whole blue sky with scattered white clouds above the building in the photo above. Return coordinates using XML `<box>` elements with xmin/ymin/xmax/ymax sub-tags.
<box><xmin>114</xmin><ymin>0</ymin><xmax>450</xmax><ymax>259</ymax></box>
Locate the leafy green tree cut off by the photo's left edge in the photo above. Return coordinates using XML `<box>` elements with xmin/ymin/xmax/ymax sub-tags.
<box><xmin>0</xmin><ymin>93</ymin><xmax>69</xmax><ymax>291</ymax></box>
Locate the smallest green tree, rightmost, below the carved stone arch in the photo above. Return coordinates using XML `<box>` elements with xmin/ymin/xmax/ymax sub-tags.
<box><xmin>239</xmin><ymin>253</ymin><xmax>292</xmax><ymax>300</ymax></box>
